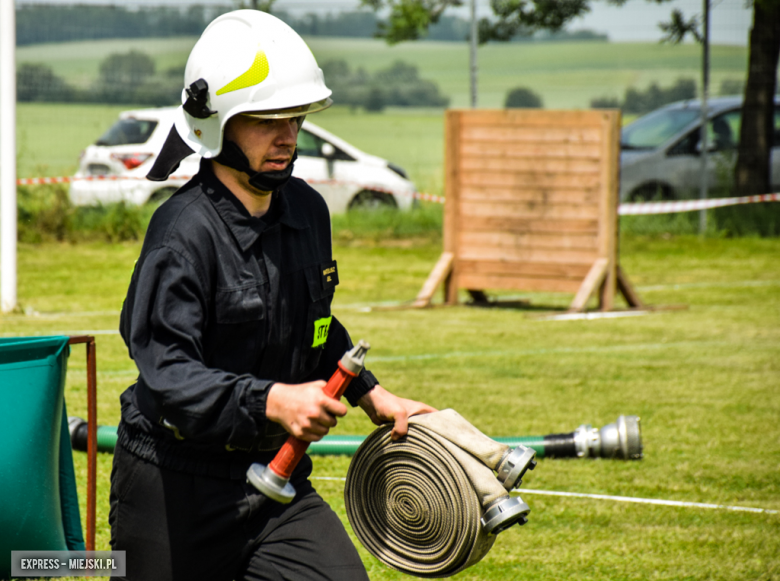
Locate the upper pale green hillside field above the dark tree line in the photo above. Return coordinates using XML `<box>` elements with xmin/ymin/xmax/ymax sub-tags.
<box><xmin>17</xmin><ymin>37</ymin><xmax>747</xmax><ymax>108</ymax></box>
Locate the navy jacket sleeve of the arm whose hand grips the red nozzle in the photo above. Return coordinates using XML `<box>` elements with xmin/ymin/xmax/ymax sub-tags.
<box><xmin>120</xmin><ymin>247</ymin><xmax>273</xmax><ymax>448</ymax></box>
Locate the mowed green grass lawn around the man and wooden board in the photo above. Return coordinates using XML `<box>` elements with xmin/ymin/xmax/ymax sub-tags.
<box><xmin>0</xmin><ymin>237</ymin><xmax>780</xmax><ymax>581</ymax></box>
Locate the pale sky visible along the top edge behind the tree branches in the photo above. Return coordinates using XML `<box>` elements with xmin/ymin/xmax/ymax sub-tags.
<box><xmin>16</xmin><ymin>0</ymin><xmax>752</xmax><ymax>46</ymax></box>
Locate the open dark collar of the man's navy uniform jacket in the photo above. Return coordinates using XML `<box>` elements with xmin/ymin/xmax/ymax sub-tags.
<box><xmin>199</xmin><ymin>159</ymin><xmax>308</xmax><ymax>251</ymax></box>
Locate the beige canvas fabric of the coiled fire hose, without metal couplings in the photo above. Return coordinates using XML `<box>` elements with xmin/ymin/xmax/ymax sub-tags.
<box><xmin>344</xmin><ymin>410</ymin><xmax>520</xmax><ymax>577</ymax></box>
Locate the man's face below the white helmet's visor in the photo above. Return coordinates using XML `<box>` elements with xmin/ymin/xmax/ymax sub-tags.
<box><xmin>225</xmin><ymin>115</ymin><xmax>300</xmax><ymax>172</ymax></box>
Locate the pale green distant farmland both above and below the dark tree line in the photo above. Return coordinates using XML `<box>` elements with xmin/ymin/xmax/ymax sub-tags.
<box><xmin>10</xmin><ymin>37</ymin><xmax>747</xmax><ymax>188</ymax></box>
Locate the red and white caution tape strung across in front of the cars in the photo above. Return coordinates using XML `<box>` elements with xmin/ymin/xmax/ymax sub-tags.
<box><xmin>16</xmin><ymin>175</ymin><xmax>780</xmax><ymax>216</ymax></box>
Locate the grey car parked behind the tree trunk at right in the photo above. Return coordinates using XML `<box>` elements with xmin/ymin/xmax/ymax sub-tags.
<box><xmin>620</xmin><ymin>97</ymin><xmax>780</xmax><ymax>201</ymax></box>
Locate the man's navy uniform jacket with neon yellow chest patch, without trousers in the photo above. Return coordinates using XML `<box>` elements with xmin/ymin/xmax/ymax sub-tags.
<box><xmin>119</xmin><ymin>161</ymin><xmax>377</xmax><ymax>474</ymax></box>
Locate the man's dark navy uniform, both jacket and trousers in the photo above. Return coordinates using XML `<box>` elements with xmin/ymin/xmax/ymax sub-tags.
<box><xmin>109</xmin><ymin>161</ymin><xmax>377</xmax><ymax>581</ymax></box>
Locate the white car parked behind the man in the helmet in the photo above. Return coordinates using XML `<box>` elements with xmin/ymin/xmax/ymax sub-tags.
<box><xmin>70</xmin><ymin>107</ymin><xmax>417</xmax><ymax>214</ymax></box>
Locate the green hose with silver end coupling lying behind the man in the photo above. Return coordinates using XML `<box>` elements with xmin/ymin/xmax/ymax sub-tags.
<box><xmin>68</xmin><ymin>416</ymin><xmax>642</xmax><ymax>460</ymax></box>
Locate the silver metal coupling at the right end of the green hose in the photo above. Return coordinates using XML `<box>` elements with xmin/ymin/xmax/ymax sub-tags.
<box><xmin>574</xmin><ymin>416</ymin><xmax>642</xmax><ymax>460</ymax></box>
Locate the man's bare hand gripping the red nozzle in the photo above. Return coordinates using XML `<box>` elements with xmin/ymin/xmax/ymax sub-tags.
<box><xmin>265</xmin><ymin>381</ymin><xmax>347</xmax><ymax>442</ymax></box>
